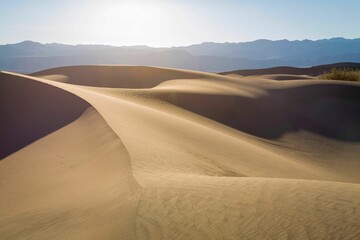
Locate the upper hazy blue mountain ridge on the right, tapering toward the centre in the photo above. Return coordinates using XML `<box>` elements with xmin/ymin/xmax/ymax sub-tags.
<box><xmin>180</xmin><ymin>38</ymin><xmax>360</xmax><ymax>60</ymax></box>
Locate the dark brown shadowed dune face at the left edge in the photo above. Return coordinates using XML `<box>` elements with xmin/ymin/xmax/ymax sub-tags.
<box><xmin>0</xmin><ymin>73</ymin><xmax>89</xmax><ymax>159</ymax></box>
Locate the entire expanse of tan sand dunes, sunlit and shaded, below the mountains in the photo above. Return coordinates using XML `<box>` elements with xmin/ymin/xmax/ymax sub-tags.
<box><xmin>0</xmin><ymin>66</ymin><xmax>360</xmax><ymax>240</ymax></box>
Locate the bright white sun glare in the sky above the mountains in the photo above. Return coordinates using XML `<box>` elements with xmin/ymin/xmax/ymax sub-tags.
<box><xmin>65</xmin><ymin>0</ymin><xmax>197</xmax><ymax>47</ymax></box>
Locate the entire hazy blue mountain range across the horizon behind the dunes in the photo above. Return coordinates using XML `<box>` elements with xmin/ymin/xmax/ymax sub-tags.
<box><xmin>0</xmin><ymin>38</ymin><xmax>360</xmax><ymax>73</ymax></box>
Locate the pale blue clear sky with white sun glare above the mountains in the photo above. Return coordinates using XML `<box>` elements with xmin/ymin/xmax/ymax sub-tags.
<box><xmin>0</xmin><ymin>0</ymin><xmax>360</xmax><ymax>46</ymax></box>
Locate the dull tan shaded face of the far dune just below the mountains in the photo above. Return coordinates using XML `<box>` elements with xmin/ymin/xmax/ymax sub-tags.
<box><xmin>32</xmin><ymin>66</ymin><xmax>208</xmax><ymax>88</ymax></box>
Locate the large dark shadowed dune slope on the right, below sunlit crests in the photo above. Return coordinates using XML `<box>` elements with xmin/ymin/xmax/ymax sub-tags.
<box><xmin>161</xmin><ymin>84</ymin><xmax>360</xmax><ymax>141</ymax></box>
